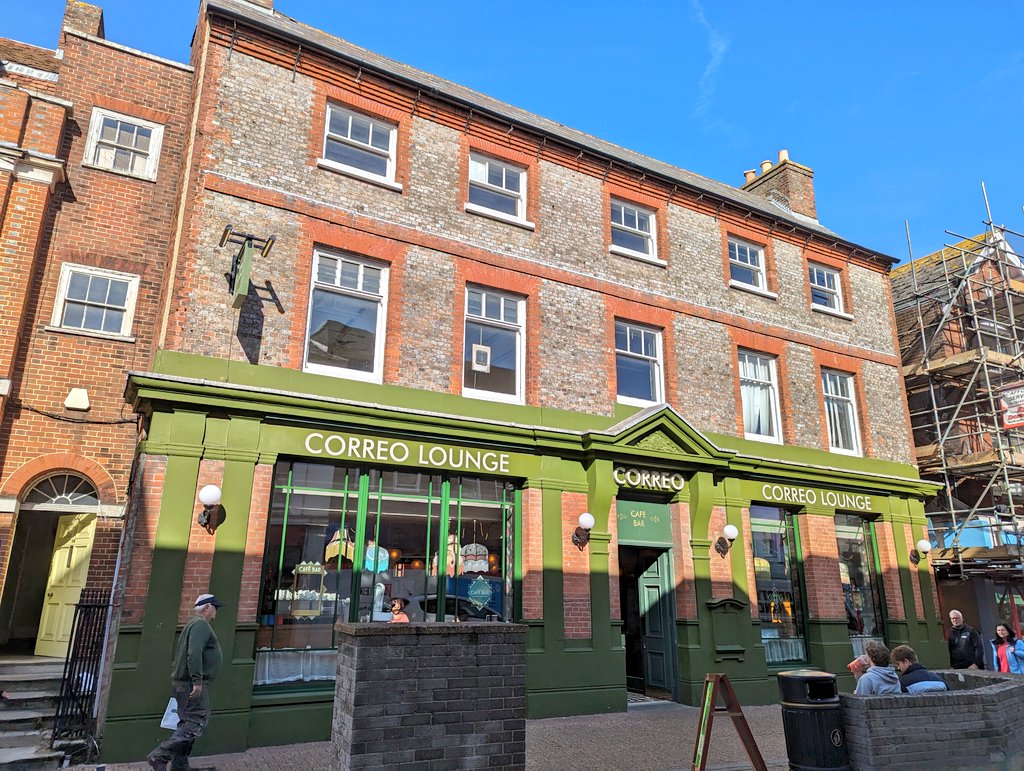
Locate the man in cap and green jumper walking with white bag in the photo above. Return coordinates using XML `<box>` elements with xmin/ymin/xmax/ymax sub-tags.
<box><xmin>146</xmin><ymin>594</ymin><xmax>224</xmax><ymax>771</ymax></box>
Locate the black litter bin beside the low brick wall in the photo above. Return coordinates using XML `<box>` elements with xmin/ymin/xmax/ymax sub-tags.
<box><xmin>778</xmin><ymin>670</ymin><xmax>850</xmax><ymax>771</ymax></box>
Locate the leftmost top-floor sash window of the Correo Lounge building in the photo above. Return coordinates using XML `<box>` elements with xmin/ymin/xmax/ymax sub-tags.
<box><xmin>324</xmin><ymin>104</ymin><xmax>398</xmax><ymax>182</ymax></box>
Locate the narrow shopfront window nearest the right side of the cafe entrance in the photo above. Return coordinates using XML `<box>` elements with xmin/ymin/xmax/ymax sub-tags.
<box><xmin>751</xmin><ymin>504</ymin><xmax>807</xmax><ymax>665</ymax></box>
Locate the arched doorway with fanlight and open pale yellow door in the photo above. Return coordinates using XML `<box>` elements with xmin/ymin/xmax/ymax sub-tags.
<box><xmin>0</xmin><ymin>473</ymin><xmax>99</xmax><ymax>658</ymax></box>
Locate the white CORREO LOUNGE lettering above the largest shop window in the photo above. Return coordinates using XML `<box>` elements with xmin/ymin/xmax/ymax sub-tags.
<box><xmin>305</xmin><ymin>431</ymin><xmax>511</xmax><ymax>474</ymax></box>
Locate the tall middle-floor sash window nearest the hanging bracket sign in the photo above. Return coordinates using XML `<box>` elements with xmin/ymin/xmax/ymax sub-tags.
<box><xmin>305</xmin><ymin>252</ymin><xmax>387</xmax><ymax>383</ymax></box>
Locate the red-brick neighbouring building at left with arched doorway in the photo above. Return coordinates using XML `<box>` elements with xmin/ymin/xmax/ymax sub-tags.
<box><xmin>0</xmin><ymin>0</ymin><xmax>191</xmax><ymax>656</ymax></box>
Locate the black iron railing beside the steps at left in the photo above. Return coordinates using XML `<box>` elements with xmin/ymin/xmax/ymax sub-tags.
<box><xmin>50</xmin><ymin>589</ymin><xmax>111</xmax><ymax>760</ymax></box>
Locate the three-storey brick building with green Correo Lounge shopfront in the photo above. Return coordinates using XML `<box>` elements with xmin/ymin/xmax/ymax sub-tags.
<box><xmin>2</xmin><ymin>0</ymin><xmax>942</xmax><ymax>760</ymax></box>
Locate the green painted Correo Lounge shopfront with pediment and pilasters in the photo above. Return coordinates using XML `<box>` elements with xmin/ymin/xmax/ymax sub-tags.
<box><xmin>102</xmin><ymin>352</ymin><xmax>944</xmax><ymax>761</ymax></box>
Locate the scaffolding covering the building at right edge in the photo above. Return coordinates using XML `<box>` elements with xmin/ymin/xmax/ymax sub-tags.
<box><xmin>892</xmin><ymin>217</ymin><xmax>1024</xmax><ymax>583</ymax></box>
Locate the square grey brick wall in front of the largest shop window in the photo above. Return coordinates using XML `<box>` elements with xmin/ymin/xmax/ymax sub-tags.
<box><xmin>331</xmin><ymin>623</ymin><xmax>526</xmax><ymax>769</ymax></box>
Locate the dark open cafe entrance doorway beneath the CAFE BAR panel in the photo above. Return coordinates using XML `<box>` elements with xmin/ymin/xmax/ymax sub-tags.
<box><xmin>618</xmin><ymin>546</ymin><xmax>677</xmax><ymax>700</ymax></box>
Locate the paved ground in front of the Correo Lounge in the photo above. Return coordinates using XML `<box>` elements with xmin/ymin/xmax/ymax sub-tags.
<box><xmin>74</xmin><ymin>701</ymin><xmax>788</xmax><ymax>771</ymax></box>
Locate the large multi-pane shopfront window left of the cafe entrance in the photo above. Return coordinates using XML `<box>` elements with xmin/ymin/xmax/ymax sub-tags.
<box><xmin>256</xmin><ymin>462</ymin><xmax>517</xmax><ymax>685</ymax></box>
